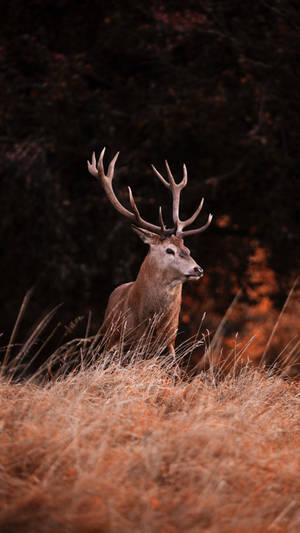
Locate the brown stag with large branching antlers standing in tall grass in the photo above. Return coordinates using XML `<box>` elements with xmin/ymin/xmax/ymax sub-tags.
<box><xmin>87</xmin><ymin>148</ymin><xmax>213</xmax><ymax>359</ymax></box>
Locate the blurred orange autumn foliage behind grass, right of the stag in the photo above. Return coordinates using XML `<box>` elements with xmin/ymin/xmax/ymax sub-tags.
<box><xmin>182</xmin><ymin>245</ymin><xmax>300</xmax><ymax>370</ymax></box>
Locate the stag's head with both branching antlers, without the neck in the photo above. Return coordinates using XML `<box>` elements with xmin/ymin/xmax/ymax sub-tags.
<box><xmin>87</xmin><ymin>148</ymin><xmax>212</xmax><ymax>285</ymax></box>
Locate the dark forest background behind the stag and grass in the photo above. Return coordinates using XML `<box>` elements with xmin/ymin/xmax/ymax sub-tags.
<box><xmin>0</xmin><ymin>0</ymin><xmax>300</xmax><ymax>366</ymax></box>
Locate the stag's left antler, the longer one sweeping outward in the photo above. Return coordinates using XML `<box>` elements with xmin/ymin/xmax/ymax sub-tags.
<box><xmin>87</xmin><ymin>148</ymin><xmax>170</xmax><ymax>236</ymax></box>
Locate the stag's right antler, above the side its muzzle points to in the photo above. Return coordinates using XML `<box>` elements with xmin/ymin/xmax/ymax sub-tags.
<box><xmin>151</xmin><ymin>161</ymin><xmax>212</xmax><ymax>237</ymax></box>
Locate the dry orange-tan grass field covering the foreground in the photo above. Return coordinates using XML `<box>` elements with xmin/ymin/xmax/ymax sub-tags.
<box><xmin>0</xmin><ymin>338</ymin><xmax>300</xmax><ymax>533</ymax></box>
